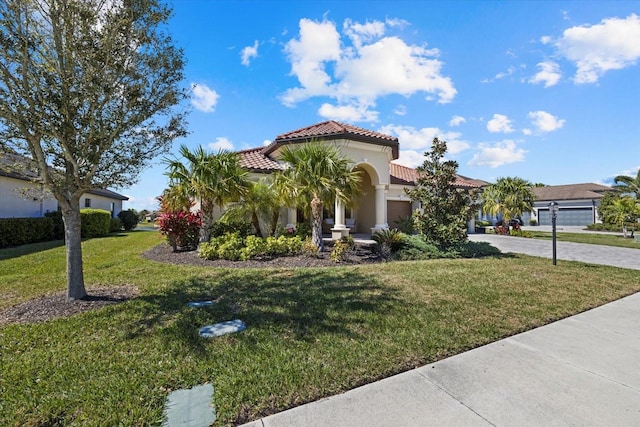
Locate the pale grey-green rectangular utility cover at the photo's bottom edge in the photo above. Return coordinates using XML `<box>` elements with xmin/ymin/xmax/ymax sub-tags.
<box><xmin>162</xmin><ymin>384</ymin><xmax>216</xmax><ymax>427</ymax></box>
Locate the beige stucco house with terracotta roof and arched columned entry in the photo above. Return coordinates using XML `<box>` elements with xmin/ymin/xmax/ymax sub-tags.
<box><xmin>238</xmin><ymin>121</ymin><xmax>486</xmax><ymax>238</ymax></box>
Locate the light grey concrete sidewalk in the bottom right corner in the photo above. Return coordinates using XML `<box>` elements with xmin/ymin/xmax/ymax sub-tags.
<box><xmin>241</xmin><ymin>293</ymin><xmax>640</xmax><ymax>427</ymax></box>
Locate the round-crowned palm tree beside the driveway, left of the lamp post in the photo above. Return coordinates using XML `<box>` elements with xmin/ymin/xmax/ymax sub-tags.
<box><xmin>482</xmin><ymin>177</ymin><xmax>535</xmax><ymax>229</ymax></box>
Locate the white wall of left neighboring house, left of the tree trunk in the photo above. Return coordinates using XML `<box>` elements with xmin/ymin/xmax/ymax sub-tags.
<box><xmin>0</xmin><ymin>176</ymin><xmax>58</xmax><ymax>218</ymax></box>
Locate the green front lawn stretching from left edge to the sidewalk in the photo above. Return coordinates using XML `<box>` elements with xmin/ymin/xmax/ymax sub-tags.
<box><xmin>0</xmin><ymin>231</ymin><xmax>640</xmax><ymax>426</ymax></box>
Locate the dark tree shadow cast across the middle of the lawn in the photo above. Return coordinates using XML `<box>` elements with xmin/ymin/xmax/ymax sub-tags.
<box><xmin>124</xmin><ymin>268</ymin><xmax>402</xmax><ymax>353</ymax></box>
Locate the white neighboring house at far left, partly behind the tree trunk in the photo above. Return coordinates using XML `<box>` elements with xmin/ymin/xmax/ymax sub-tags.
<box><xmin>0</xmin><ymin>153</ymin><xmax>129</xmax><ymax>218</ymax></box>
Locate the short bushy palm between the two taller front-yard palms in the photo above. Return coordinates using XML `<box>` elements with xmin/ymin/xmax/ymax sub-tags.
<box><xmin>224</xmin><ymin>179</ymin><xmax>283</xmax><ymax>237</ymax></box>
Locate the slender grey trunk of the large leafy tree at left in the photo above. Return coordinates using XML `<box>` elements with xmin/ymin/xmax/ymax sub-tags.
<box><xmin>62</xmin><ymin>201</ymin><xmax>87</xmax><ymax>300</ymax></box>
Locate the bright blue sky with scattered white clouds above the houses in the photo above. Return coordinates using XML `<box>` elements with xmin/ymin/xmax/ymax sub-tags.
<box><xmin>118</xmin><ymin>0</ymin><xmax>640</xmax><ymax>210</ymax></box>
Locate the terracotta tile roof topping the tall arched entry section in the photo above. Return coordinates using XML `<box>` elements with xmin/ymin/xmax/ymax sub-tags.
<box><xmin>264</xmin><ymin>120</ymin><xmax>399</xmax><ymax>159</ymax></box>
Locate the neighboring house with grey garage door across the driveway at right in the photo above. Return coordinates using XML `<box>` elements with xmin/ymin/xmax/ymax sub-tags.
<box><xmin>522</xmin><ymin>183</ymin><xmax>611</xmax><ymax>226</ymax></box>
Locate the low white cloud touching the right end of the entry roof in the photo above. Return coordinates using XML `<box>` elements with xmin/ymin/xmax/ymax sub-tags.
<box><xmin>379</xmin><ymin>125</ymin><xmax>469</xmax><ymax>154</ymax></box>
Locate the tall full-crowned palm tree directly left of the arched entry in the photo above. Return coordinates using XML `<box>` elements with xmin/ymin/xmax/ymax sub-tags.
<box><xmin>276</xmin><ymin>141</ymin><xmax>361</xmax><ymax>251</ymax></box>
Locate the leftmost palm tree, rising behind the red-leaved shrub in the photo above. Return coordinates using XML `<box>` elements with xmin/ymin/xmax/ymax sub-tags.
<box><xmin>165</xmin><ymin>145</ymin><xmax>248</xmax><ymax>242</ymax></box>
